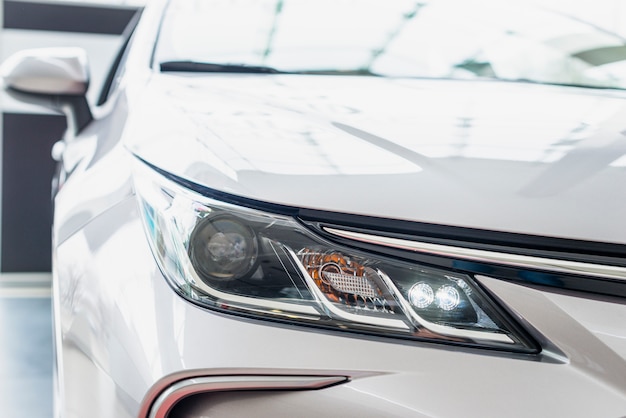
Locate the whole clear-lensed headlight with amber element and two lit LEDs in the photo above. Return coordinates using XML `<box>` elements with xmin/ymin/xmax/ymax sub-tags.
<box><xmin>135</xmin><ymin>163</ymin><xmax>537</xmax><ymax>352</ymax></box>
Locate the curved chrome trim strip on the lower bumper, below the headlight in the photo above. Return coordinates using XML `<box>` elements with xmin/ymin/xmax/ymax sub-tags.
<box><xmin>148</xmin><ymin>375</ymin><xmax>349</xmax><ymax>418</ymax></box>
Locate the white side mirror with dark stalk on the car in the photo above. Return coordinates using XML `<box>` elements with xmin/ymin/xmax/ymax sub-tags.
<box><xmin>0</xmin><ymin>48</ymin><xmax>93</xmax><ymax>134</ymax></box>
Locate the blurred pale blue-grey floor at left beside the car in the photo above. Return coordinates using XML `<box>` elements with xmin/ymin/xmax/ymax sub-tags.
<box><xmin>0</xmin><ymin>274</ymin><xmax>52</xmax><ymax>418</ymax></box>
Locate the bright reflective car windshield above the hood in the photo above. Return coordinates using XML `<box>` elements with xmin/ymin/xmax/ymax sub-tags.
<box><xmin>155</xmin><ymin>0</ymin><xmax>626</xmax><ymax>89</ymax></box>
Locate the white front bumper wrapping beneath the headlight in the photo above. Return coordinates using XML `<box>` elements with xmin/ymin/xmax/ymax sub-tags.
<box><xmin>55</xmin><ymin>197</ymin><xmax>626</xmax><ymax>417</ymax></box>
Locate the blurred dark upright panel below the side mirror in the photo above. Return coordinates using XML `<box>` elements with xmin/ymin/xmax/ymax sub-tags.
<box><xmin>0</xmin><ymin>113</ymin><xmax>66</xmax><ymax>272</ymax></box>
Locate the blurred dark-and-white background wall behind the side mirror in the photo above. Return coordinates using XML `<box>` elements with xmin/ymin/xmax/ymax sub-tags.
<box><xmin>0</xmin><ymin>0</ymin><xmax>138</xmax><ymax>273</ymax></box>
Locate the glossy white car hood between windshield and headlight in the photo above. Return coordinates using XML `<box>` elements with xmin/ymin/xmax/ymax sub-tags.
<box><xmin>127</xmin><ymin>74</ymin><xmax>626</xmax><ymax>244</ymax></box>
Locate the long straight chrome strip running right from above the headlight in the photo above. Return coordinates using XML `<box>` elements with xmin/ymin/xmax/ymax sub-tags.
<box><xmin>323</xmin><ymin>227</ymin><xmax>626</xmax><ymax>281</ymax></box>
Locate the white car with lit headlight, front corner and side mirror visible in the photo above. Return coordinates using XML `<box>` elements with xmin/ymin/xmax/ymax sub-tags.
<box><xmin>3</xmin><ymin>0</ymin><xmax>626</xmax><ymax>418</ymax></box>
